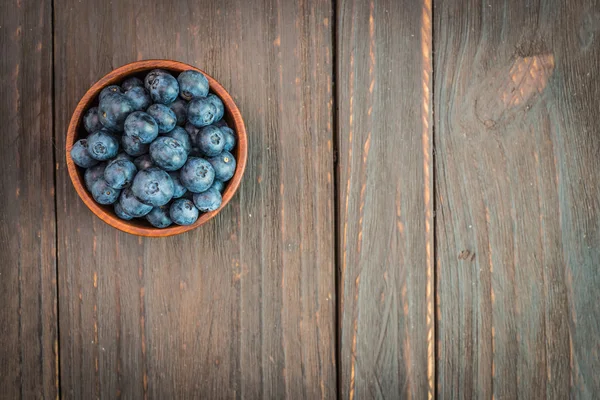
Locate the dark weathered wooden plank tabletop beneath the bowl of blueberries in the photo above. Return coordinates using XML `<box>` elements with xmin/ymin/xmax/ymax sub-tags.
<box><xmin>0</xmin><ymin>0</ymin><xmax>600</xmax><ymax>399</ymax></box>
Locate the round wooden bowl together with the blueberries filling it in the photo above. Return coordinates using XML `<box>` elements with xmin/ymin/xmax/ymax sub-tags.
<box><xmin>66</xmin><ymin>60</ymin><xmax>248</xmax><ymax>237</ymax></box>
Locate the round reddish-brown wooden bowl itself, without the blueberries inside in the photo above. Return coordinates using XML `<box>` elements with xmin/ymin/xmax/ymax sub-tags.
<box><xmin>66</xmin><ymin>60</ymin><xmax>248</xmax><ymax>237</ymax></box>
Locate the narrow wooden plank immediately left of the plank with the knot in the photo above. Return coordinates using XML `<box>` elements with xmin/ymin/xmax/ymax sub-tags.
<box><xmin>336</xmin><ymin>0</ymin><xmax>435</xmax><ymax>399</ymax></box>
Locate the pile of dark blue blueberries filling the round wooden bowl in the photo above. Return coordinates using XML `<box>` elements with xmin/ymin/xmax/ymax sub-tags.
<box><xmin>71</xmin><ymin>69</ymin><xmax>236</xmax><ymax>228</ymax></box>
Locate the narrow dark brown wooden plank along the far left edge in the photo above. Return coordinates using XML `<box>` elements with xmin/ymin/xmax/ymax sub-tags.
<box><xmin>0</xmin><ymin>1</ymin><xmax>58</xmax><ymax>399</ymax></box>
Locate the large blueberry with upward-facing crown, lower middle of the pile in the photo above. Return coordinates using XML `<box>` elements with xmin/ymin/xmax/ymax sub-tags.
<box><xmin>131</xmin><ymin>167</ymin><xmax>175</xmax><ymax>207</ymax></box>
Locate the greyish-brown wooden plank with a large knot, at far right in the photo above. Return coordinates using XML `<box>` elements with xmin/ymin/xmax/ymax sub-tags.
<box><xmin>434</xmin><ymin>0</ymin><xmax>600</xmax><ymax>399</ymax></box>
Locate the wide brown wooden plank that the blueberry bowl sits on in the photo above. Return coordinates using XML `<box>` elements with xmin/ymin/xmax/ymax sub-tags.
<box><xmin>54</xmin><ymin>0</ymin><xmax>336</xmax><ymax>398</ymax></box>
